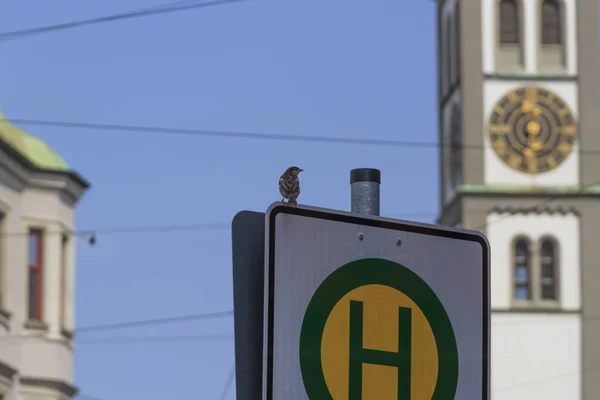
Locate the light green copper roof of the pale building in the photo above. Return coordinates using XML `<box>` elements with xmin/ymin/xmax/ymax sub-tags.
<box><xmin>0</xmin><ymin>111</ymin><xmax>69</xmax><ymax>171</ymax></box>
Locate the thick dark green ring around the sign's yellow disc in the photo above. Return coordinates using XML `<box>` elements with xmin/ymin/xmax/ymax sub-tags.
<box><xmin>300</xmin><ymin>258</ymin><xmax>458</xmax><ymax>400</ymax></box>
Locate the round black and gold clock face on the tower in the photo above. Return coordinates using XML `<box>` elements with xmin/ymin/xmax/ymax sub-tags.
<box><xmin>489</xmin><ymin>87</ymin><xmax>577</xmax><ymax>174</ymax></box>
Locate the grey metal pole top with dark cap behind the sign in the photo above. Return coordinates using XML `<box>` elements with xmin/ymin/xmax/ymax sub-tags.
<box><xmin>350</xmin><ymin>168</ymin><xmax>381</xmax><ymax>216</ymax></box>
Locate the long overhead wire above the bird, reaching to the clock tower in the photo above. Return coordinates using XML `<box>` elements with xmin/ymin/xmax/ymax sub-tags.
<box><xmin>0</xmin><ymin>118</ymin><xmax>600</xmax><ymax>155</ymax></box>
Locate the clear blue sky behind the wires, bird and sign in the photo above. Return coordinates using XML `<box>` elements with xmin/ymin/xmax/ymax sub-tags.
<box><xmin>0</xmin><ymin>0</ymin><xmax>438</xmax><ymax>400</ymax></box>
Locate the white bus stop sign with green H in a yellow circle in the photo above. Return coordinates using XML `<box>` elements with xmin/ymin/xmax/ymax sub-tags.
<box><xmin>263</xmin><ymin>204</ymin><xmax>490</xmax><ymax>400</ymax></box>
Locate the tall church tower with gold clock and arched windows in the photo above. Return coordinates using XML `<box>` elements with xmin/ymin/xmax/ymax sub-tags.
<box><xmin>437</xmin><ymin>0</ymin><xmax>600</xmax><ymax>400</ymax></box>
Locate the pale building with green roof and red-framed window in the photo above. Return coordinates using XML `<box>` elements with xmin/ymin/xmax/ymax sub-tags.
<box><xmin>0</xmin><ymin>114</ymin><xmax>89</xmax><ymax>400</ymax></box>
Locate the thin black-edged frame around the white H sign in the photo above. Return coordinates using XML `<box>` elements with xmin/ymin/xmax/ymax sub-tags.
<box><xmin>262</xmin><ymin>202</ymin><xmax>491</xmax><ymax>400</ymax></box>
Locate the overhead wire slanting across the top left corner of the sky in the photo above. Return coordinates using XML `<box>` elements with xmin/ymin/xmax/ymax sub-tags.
<box><xmin>0</xmin><ymin>0</ymin><xmax>244</xmax><ymax>41</ymax></box>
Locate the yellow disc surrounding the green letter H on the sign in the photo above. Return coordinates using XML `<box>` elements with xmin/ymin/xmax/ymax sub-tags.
<box><xmin>321</xmin><ymin>285</ymin><xmax>438</xmax><ymax>400</ymax></box>
